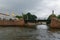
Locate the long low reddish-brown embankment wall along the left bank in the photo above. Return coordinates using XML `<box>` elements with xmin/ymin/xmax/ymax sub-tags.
<box><xmin>0</xmin><ymin>19</ymin><xmax>25</xmax><ymax>26</ymax></box>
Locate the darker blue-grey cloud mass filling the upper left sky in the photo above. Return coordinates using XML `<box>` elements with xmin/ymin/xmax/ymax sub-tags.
<box><xmin>0</xmin><ymin>0</ymin><xmax>39</xmax><ymax>13</ymax></box>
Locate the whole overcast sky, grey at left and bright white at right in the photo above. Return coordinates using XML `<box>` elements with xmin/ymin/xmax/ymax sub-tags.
<box><xmin>0</xmin><ymin>0</ymin><xmax>60</xmax><ymax>18</ymax></box>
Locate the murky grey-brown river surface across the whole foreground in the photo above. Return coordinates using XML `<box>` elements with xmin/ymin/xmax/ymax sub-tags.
<box><xmin>0</xmin><ymin>25</ymin><xmax>60</xmax><ymax>40</ymax></box>
